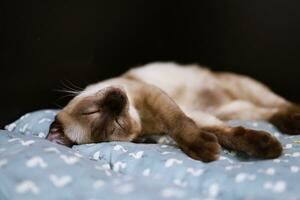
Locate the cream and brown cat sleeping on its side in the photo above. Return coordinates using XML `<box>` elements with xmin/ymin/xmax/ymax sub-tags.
<box><xmin>47</xmin><ymin>63</ymin><xmax>300</xmax><ymax>162</ymax></box>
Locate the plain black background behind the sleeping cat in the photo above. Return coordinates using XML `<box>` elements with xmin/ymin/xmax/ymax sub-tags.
<box><xmin>0</xmin><ymin>0</ymin><xmax>300</xmax><ymax>126</ymax></box>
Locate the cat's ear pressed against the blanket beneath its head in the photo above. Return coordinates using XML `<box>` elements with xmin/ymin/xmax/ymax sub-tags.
<box><xmin>46</xmin><ymin>119</ymin><xmax>75</xmax><ymax>147</ymax></box>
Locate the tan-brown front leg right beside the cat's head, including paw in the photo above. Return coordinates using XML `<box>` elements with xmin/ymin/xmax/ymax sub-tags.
<box><xmin>132</xmin><ymin>84</ymin><xmax>220</xmax><ymax>162</ymax></box>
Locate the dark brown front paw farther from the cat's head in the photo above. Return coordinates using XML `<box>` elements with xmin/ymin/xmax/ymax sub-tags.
<box><xmin>234</xmin><ymin>127</ymin><xmax>282</xmax><ymax>158</ymax></box>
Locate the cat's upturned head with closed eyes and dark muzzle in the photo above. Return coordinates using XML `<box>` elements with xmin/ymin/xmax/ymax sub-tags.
<box><xmin>46</xmin><ymin>86</ymin><xmax>141</xmax><ymax>146</ymax></box>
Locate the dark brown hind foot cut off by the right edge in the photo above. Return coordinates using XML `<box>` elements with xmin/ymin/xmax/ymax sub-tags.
<box><xmin>270</xmin><ymin>106</ymin><xmax>300</xmax><ymax>135</ymax></box>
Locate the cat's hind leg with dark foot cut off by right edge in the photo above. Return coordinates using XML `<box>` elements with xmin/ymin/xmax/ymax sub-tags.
<box><xmin>218</xmin><ymin>73</ymin><xmax>300</xmax><ymax>134</ymax></box>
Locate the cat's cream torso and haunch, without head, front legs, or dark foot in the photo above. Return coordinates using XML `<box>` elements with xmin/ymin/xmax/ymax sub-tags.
<box><xmin>125</xmin><ymin>63</ymin><xmax>287</xmax><ymax>120</ymax></box>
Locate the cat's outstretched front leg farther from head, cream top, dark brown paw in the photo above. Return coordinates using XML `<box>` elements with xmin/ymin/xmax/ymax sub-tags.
<box><xmin>185</xmin><ymin>108</ymin><xmax>282</xmax><ymax>158</ymax></box>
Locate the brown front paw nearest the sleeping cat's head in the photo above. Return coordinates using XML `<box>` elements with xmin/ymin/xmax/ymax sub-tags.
<box><xmin>179</xmin><ymin>132</ymin><xmax>220</xmax><ymax>162</ymax></box>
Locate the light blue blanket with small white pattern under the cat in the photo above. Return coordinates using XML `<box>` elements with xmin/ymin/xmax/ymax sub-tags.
<box><xmin>0</xmin><ymin>110</ymin><xmax>300</xmax><ymax>200</ymax></box>
